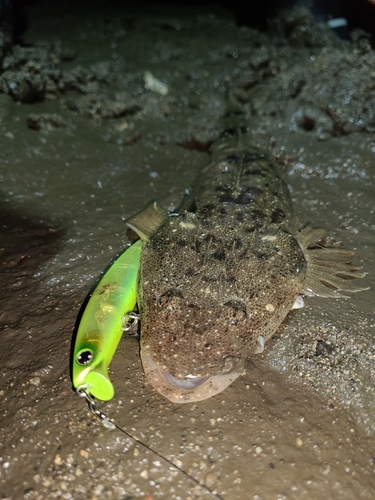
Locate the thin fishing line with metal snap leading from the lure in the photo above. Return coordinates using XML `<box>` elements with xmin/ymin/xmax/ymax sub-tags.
<box><xmin>77</xmin><ymin>388</ymin><xmax>224</xmax><ymax>500</ymax></box>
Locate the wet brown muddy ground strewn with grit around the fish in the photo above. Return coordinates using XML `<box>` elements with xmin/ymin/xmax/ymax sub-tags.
<box><xmin>0</xmin><ymin>2</ymin><xmax>375</xmax><ymax>500</ymax></box>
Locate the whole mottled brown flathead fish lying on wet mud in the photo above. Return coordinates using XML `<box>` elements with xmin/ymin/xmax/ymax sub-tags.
<box><xmin>128</xmin><ymin>95</ymin><xmax>366</xmax><ymax>403</ymax></box>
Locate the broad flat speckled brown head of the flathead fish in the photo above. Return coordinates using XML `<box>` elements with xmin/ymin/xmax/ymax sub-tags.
<box><xmin>138</xmin><ymin>218</ymin><xmax>306</xmax><ymax>403</ymax></box>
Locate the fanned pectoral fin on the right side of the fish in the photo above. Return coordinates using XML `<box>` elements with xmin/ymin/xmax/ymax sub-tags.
<box><xmin>298</xmin><ymin>226</ymin><xmax>368</xmax><ymax>298</ymax></box>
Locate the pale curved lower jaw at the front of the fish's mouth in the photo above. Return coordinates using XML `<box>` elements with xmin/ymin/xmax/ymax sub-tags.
<box><xmin>141</xmin><ymin>352</ymin><xmax>241</xmax><ymax>403</ymax></box>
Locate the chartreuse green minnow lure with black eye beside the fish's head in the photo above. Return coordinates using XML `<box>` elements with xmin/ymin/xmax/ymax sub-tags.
<box><xmin>72</xmin><ymin>240</ymin><xmax>143</xmax><ymax>401</ymax></box>
